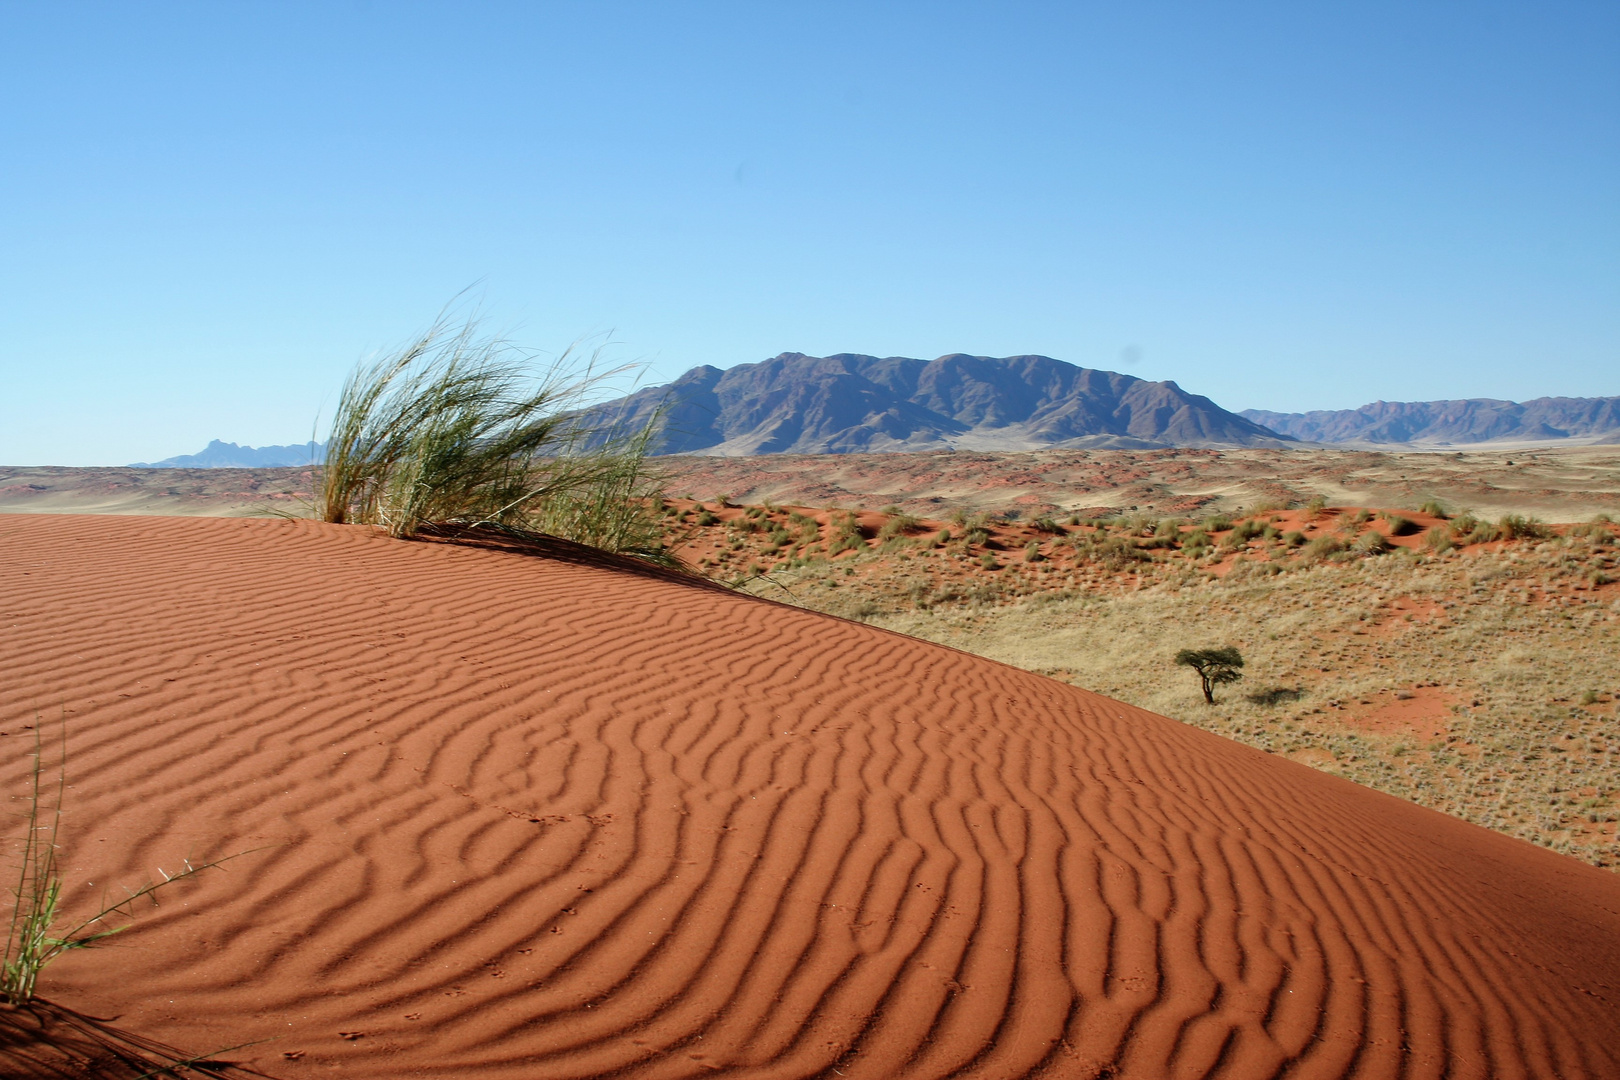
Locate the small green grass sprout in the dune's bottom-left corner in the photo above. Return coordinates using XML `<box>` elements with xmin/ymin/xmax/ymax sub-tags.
<box><xmin>0</xmin><ymin>724</ymin><xmax>235</xmax><ymax>1006</ymax></box>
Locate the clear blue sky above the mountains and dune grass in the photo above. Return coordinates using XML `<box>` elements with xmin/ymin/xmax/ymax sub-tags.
<box><xmin>0</xmin><ymin>2</ymin><xmax>1620</xmax><ymax>465</ymax></box>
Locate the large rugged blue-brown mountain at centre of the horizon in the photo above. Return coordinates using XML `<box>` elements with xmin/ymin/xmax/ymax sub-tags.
<box><xmin>593</xmin><ymin>353</ymin><xmax>1291</xmax><ymax>457</ymax></box>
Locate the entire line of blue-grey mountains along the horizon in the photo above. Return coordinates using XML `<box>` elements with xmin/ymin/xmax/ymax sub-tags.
<box><xmin>138</xmin><ymin>353</ymin><xmax>1620</xmax><ymax>468</ymax></box>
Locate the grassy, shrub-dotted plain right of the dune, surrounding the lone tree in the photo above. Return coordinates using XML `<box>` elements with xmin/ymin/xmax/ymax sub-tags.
<box><xmin>651</xmin><ymin>498</ymin><xmax>1620</xmax><ymax>865</ymax></box>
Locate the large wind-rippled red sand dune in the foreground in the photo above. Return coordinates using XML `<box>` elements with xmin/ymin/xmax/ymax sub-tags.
<box><xmin>0</xmin><ymin>515</ymin><xmax>1620</xmax><ymax>1078</ymax></box>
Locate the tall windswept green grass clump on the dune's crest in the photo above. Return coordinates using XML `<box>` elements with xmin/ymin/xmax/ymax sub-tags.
<box><xmin>318</xmin><ymin>317</ymin><xmax>672</xmax><ymax>562</ymax></box>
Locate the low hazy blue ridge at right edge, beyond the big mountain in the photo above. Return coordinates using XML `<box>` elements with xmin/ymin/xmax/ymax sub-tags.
<box><xmin>1243</xmin><ymin>397</ymin><xmax>1620</xmax><ymax>445</ymax></box>
